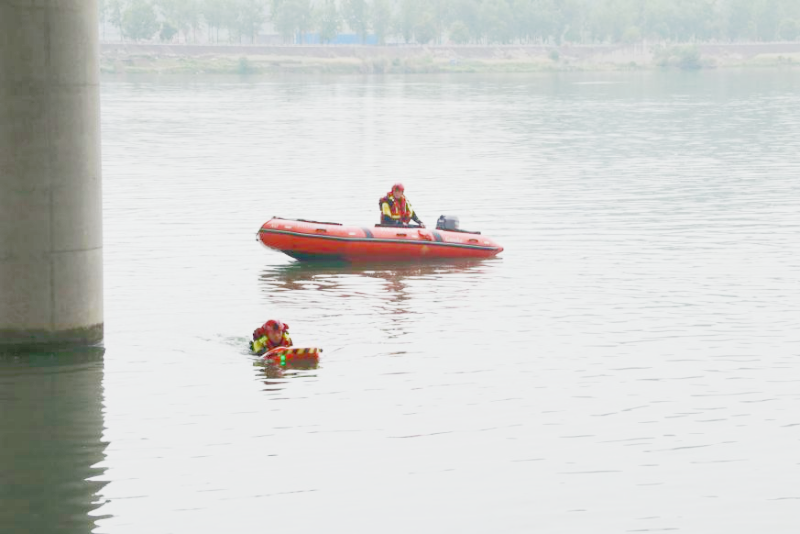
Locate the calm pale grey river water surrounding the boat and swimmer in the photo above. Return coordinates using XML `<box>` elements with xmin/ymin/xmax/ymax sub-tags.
<box><xmin>0</xmin><ymin>70</ymin><xmax>800</xmax><ymax>534</ymax></box>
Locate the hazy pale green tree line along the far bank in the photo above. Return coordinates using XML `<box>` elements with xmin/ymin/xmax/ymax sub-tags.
<box><xmin>99</xmin><ymin>0</ymin><xmax>800</xmax><ymax>44</ymax></box>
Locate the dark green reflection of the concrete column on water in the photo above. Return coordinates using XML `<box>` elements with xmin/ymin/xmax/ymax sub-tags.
<box><xmin>0</xmin><ymin>348</ymin><xmax>107</xmax><ymax>534</ymax></box>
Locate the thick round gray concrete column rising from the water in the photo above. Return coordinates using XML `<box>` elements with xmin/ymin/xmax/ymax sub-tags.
<box><xmin>0</xmin><ymin>0</ymin><xmax>103</xmax><ymax>345</ymax></box>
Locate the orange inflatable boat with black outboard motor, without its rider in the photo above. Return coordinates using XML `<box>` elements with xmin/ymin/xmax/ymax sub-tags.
<box><xmin>258</xmin><ymin>215</ymin><xmax>503</xmax><ymax>262</ymax></box>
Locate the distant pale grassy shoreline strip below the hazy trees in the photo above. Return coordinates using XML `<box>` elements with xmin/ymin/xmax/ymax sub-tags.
<box><xmin>100</xmin><ymin>42</ymin><xmax>800</xmax><ymax>75</ymax></box>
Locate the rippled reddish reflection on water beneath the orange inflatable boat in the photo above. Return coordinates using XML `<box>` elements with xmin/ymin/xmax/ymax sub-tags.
<box><xmin>259</xmin><ymin>258</ymin><xmax>496</xmax><ymax>344</ymax></box>
